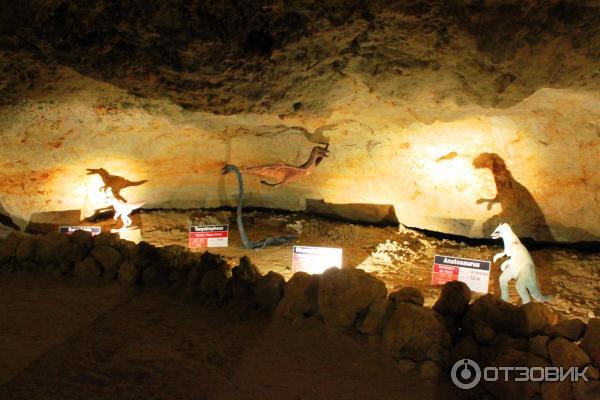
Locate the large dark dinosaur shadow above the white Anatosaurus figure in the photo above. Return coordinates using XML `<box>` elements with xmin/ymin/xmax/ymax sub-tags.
<box><xmin>473</xmin><ymin>153</ymin><xmax>554</xmax><ymax>242</ymax></box>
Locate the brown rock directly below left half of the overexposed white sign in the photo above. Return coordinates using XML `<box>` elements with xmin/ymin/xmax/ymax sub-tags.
<box><xmin>275</xmin><ymin>272</ymin><xmax>319</xmax><ymax>319</ymax></box>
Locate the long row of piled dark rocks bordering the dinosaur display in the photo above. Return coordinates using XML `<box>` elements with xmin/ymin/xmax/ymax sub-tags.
<box><xmin>0</xmin><ymin>231</ymin><xmax>600</xmax><ymax>400</ymax></box>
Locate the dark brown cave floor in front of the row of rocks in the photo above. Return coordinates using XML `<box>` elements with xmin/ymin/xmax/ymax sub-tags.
<box><xmin>0</xmin><ymin>274</ymin><xmax>455</xmax><ymax>400</ymax></box>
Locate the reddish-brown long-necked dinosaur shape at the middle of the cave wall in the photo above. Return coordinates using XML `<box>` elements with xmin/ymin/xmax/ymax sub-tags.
<box><xmin>240</xmin><ymin>145</ymin><xmax>329</xmax><ymax>186</ymax></box>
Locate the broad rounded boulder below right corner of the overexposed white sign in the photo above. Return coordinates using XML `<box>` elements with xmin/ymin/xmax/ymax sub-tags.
<box><xmin>318</xmin><ymin>268</ymin><xmax>387</xmax><ymax>329</ymax></box>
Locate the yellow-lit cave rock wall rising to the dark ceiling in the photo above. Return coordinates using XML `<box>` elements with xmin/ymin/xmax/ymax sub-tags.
<box><xmin>0</xmin><ymin>1</ymin><xmax>600</xmax><ymax>241</ymax></box>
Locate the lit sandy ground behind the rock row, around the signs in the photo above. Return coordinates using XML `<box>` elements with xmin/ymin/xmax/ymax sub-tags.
<box><xmin>130</xmin><ymin>211</ymin><xmax>600</xmax><ymax>321</ymax></box>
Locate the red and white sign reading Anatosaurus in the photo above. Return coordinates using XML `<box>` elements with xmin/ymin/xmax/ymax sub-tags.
<box><xmin>431</xmin><ymin>256</ymin><xmax>491</xmax><ymax>293</ymax></box>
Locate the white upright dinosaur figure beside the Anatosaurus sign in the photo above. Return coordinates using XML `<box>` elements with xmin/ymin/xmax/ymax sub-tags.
<box><xmin>491</xmin><ymin>223</ymin><xmax>552</xmax><ymax>304</ymax></box>
